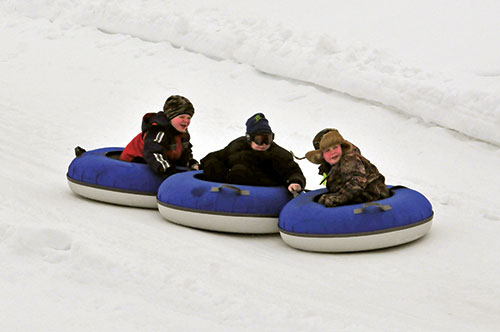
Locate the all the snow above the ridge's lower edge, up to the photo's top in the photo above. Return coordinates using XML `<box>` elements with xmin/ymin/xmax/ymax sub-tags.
<box><xmin>4</xmin><ymin>0</ymin><xmax>500</xmax><ymax>145</ymax></box>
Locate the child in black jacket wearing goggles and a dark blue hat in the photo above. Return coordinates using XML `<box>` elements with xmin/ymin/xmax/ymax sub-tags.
<box><xmin>200</xmin><ymin>113</ymin><xmax>306</xmax><ymax>192</ymax></box>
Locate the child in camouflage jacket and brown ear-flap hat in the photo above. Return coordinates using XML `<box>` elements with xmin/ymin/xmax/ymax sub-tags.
<box><xmin>306</xmin><ymin>129</ymin><xmax>389</xmax><ymax>207</ymax></box>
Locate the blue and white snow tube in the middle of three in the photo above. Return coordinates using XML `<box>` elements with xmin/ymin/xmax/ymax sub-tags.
<box><xmin>157</xmin><ymin>171</ymin><xmax>292</xmax><ymax>234</ymax></box>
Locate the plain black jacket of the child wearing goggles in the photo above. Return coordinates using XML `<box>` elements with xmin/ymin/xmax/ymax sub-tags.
<box><xmin>200</xmin><ymin>136</ymin><xmax>306</xmax><ymax>188</ymax></box>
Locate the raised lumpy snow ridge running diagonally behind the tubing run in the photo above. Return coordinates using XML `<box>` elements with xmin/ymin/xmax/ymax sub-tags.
<box><xmin>0</xmin><ymin>0</ymin><xmax>500</xmax><ymax>145</ymax></box>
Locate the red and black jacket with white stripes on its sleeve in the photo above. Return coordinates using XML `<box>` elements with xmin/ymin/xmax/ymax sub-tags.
<box><xmin>120</xmin><ymin>112</ymin><xmax>197</xmax><ymax>176</ymax></box>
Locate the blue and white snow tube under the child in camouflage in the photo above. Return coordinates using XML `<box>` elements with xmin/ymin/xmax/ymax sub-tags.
<box><xmin>278</xmin><ymin>186</ymin><xmax>434</xmax><ymax>252</ymax></box>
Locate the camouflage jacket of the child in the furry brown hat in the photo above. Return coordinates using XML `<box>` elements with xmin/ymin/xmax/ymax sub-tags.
<box><xmin>318</xmin><ymin>149</ymin><xmax>389</xmax><ymax>207</ymax></box>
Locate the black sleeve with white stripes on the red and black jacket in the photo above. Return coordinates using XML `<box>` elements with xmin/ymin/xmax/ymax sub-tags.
<box><xmin>142</xmin><ymin>127</ymin><xmax>175</xmax><ymax>175</ymax></box>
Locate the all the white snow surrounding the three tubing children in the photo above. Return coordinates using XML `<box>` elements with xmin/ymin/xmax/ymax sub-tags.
<box><xmin>0</xmin><ymin>0</ymin><xmax>500</xmax><ymax>331</ymax></box>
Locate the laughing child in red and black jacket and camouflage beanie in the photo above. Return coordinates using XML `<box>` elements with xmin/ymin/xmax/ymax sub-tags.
<box><xmin>120</xmin><ymin>95</ymin><xmax>198</xmax><ymax>177</ymax></box>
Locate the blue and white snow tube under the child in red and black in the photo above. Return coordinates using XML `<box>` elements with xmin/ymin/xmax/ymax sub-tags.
<box><xmin>67</xmin><ymin>147</ymin><xmax>163</xmax><ymax>209</ymax></box>
